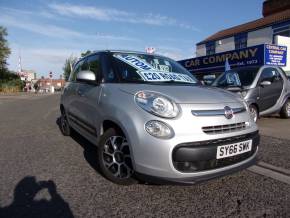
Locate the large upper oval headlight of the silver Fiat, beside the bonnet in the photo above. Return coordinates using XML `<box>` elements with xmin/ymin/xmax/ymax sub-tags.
<box><xmin>135</xmin><ymin>91</ymin><xmax>179</xmax><ymax>118</ymax></box>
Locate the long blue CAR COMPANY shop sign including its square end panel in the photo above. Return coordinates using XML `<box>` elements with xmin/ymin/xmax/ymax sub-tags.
<box><xmin>179</xmin><ymin>44</ymin><xmax>287</xmax><ymax>73</ymax></box>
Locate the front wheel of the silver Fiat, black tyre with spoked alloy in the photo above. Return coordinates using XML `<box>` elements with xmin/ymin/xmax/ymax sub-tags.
<box><xmin>98</xmin><ymin>128</ymin><xmax>137</xmax><ymax>185</ymax></box>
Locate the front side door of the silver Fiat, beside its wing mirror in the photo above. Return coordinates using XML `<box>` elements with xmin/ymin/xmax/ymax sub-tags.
<box><xmin>78</xmin><ymin>54</ymin><xmax>101</xmax><ymax>136</ymax></box>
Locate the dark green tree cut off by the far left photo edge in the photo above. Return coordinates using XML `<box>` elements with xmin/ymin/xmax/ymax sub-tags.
<box><xmin>0</xmin><ymin>26</ymin><xmax>11</xmax><ymax>79</ymax></box>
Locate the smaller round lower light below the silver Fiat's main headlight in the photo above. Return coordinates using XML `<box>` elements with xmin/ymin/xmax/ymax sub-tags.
<box><xmin>145</xmin><ymin>120</ymin><xmax>174</xmax><ymax>139</ymax></box>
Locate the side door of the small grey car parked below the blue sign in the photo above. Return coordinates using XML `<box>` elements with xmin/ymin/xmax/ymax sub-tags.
<box><xmin>258</xmin><ymin>67</ymin><xmax>283</xmax><ymax>111</ymax></box>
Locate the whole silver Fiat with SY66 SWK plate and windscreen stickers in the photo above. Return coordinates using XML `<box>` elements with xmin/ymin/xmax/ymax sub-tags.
<box><xmin>60</xmin><ymin>51</ymin><xmax>259</xmax><ymax>185</ymax></box>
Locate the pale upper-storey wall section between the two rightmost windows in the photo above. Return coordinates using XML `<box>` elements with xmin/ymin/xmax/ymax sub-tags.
<box><xmin>247</xmin><ymin>27</ymin><xmax>273</xmax><ymax>47</ymax></box>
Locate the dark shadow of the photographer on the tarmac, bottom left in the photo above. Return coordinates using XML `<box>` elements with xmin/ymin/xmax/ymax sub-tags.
<box><xmin>0</xmin><ymin>176</ymin><xmax>74</xmax><ymax>218</ymax></box>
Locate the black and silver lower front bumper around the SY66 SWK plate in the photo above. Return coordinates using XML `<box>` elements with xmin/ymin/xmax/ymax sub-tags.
<box><xmin>133</xmin><ymin>131</ymin><xmax>260</xmax><ymax>184</ymax></box>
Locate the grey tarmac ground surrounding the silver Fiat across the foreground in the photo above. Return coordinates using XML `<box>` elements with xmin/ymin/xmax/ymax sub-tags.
<box><xmin>0</xmin><ymin>94</ymin><xmax>290</xmax><ymax>218</ymax></box>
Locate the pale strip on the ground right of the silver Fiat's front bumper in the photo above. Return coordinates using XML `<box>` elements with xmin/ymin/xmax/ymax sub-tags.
<box><xmin>248</xmin><ymin>163</ymin><xmax>290</xmax><ymax>185</ymax></box>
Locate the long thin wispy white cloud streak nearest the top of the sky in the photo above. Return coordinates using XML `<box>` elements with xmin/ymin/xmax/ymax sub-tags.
<box><xmin>48</xmin><ymin>3</ymin><xmax>199</xmax><ymax>31</ymax></box>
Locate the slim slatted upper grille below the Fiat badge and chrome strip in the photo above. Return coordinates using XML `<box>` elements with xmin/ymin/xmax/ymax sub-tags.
<box><xmin>202</xmin><ymin>122</ymin><xmax>247</xmax><ymax>135</ymax></box>
